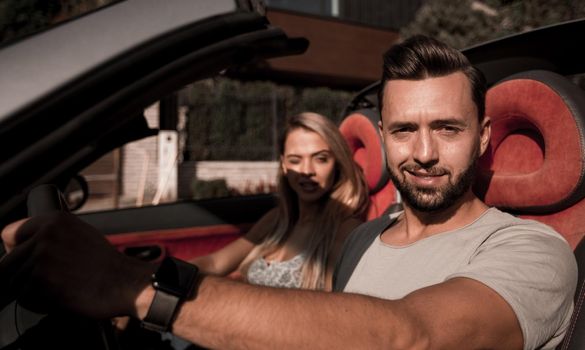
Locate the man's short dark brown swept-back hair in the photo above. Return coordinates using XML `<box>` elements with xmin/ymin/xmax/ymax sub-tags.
<box><xmin>378</xmin><ymin>35</ymin><xmax>487</xmax><ymax>122</ymax></box>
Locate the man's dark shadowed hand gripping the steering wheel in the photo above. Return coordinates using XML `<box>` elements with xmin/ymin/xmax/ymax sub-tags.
<box><xmin>0</xmin><ymin>213</ymin><xmax>154</xmax><ymax>318</ymax></box>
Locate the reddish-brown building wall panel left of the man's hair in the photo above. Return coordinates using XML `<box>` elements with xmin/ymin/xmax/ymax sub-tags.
<box><xmin>267</xmin><ymin>9</ymin><xmax>399</xmax><ymax>89</ymax></box>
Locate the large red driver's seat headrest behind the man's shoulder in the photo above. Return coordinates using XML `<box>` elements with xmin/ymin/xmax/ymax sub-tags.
<box><xmin>475</xmin><ymin>71</ymin><xmax>585</xmax><ymax>248</ymax></box>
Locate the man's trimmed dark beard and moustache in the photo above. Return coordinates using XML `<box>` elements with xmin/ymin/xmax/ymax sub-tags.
<box><xmin>388</xmin><ymin>154</ymin><xmax>479</xmax><ymax>213</ymax></box>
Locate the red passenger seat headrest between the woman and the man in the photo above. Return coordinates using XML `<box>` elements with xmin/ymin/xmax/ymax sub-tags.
<box><xmin>339</xmin><ymin>110</ymin><xmax>397</xmax><ymax>220</ymax></box>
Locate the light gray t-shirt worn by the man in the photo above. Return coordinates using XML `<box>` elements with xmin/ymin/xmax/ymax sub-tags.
<box><xmin>343</xmin><ymin>208</ymin><xmax>577</xmax><ymax>349</ymax></box>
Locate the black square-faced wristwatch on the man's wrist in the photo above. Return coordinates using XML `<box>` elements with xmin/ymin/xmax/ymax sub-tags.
<box><xmin>142</xmin><ymin>257</ymin><xmax>199</xmax><ymax>332</ymax></box>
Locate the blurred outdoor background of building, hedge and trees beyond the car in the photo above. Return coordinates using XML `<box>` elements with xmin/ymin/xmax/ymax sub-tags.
<box><xmin>0</xmin><ymin>0</ymin><xmax>585</xmax><ymax>211</ymax></box>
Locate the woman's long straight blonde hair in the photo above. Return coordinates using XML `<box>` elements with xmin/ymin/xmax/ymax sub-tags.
<box><xmin>240</xmin><ymin>112</ymin><xmax>368</xmax><ymax>289</ymax></box>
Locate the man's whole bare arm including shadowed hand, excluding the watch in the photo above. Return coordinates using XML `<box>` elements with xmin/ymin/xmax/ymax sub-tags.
<box><xmin>0</xmin><ymin>214</ymin><xmax>523</xmax><ymax>349</ymax></box>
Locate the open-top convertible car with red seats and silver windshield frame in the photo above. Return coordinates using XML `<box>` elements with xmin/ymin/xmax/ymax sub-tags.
<box><xmin>0</xmin><ymin>0</ymin><xmax>585</xmax><ymax>349</ymax></box>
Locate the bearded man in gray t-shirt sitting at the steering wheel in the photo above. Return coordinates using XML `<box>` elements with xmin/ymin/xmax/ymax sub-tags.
<box><xmin>0</xmin><ymin>37</ymin><xmax>577</xmax><ymax>349</ymax></box>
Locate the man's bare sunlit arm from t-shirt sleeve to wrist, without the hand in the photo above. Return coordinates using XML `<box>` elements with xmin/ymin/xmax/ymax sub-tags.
<box><xmin>137</xmin><ymin>277</ymin><xmax>523</xmax><ymax>349</ymax></box>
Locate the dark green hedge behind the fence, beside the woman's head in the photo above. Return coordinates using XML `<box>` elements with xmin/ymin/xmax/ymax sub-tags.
<box><xmin>181</xmin><ymin>78</ymin><xmax>352</xmax><ymax>161</ymax></box>
